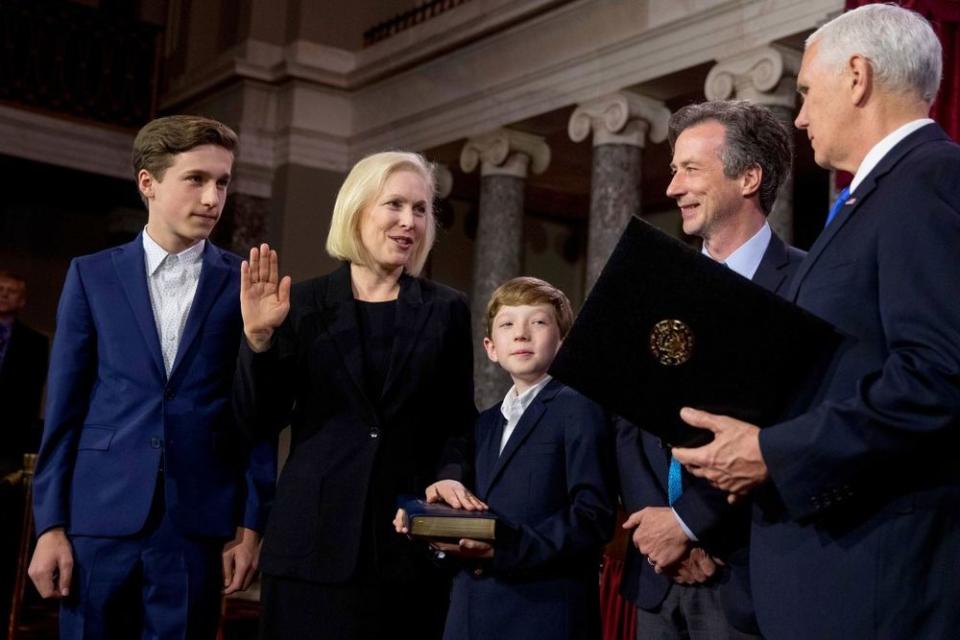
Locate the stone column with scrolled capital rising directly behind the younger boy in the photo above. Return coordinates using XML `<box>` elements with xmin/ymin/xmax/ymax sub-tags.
<box><xmin>460</xmin><ymin>129</ymin><xmax>550</xmax><ymax>409</ymax></box>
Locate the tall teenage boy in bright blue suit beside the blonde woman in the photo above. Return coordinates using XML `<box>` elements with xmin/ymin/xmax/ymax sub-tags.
<box><xmin>29</xmin><ymin>116</ymin><xmax>274</xmax><ymax>638</ymax></box>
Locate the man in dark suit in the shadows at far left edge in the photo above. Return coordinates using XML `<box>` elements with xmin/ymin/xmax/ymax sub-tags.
<box><xmin>0</xmin><ymin>271</ymin><xmax>49</xmax><ymax>622</ymax></box>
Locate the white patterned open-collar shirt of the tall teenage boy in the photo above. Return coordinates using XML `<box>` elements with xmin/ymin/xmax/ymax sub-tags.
<box><xmin>143</xmin><ymin>229</ymin><xmax>206</xmax><ymax>376</ymax></box>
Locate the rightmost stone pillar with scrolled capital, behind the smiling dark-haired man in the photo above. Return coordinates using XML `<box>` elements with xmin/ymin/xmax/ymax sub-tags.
<box><xmin>704</xmin><ymin>45</ymin><xmax>802</xmax><ymax>242</ymax></box>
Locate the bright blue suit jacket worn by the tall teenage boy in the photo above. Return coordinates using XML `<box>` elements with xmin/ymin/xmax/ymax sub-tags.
<box><xmin>34</xmin><ymin>235</ymin><xmax>276</xmax><ymax>537</ymax></box>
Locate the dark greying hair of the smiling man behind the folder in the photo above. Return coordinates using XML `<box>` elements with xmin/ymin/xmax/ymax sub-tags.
<box><xmin>667</xmin><ymin>100</ymin><xmax>793</xmax><ymax>215</ymax></box>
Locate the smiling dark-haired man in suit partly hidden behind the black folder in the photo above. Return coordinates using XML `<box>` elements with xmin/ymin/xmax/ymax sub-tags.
<box><xmin>617</xmin><ymin>101</ymin><xmax>803</xmax><ymax>639</ymax></box>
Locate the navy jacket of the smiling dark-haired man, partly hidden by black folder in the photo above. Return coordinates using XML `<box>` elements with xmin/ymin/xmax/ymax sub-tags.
<box><xmin>615</xmin><ymin>234</ymin><xmax>805</xmax><ymax>632</ymax></box>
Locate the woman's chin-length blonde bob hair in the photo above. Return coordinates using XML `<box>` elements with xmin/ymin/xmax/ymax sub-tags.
<box><xmin>327</xmin><ymin>151</ymin><xmax>437</xmax><ymax>276</ymax></box>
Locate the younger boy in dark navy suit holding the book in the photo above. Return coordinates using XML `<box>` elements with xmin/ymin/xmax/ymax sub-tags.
<box><xmin>398</xmin><ymin>277</ymin><xmax>615</xmax><ymax>640</ymax></box>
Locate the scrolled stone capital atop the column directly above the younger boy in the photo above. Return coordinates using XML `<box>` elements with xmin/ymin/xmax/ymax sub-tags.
<box><xmin>460</xmin><ymin>129</ymin><xmax>550</xmax><ymax>178</ymax></box>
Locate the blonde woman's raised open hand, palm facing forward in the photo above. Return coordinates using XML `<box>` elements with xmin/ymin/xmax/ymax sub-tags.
<box><xmin>240</xmin><ymin>243</ymin><xmax>291</xmax><ymax>353</ymax></box>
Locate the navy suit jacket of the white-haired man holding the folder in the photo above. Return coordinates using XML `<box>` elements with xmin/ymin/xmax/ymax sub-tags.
<box><xmin>750</xmin><ymin>125</ymin><xmax>960</xmax><ymax>638</ymax></box>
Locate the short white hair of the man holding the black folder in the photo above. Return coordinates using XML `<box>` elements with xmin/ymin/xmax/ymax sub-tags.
<box><xmin>807</xmin><ymin>4</ymin><xmax>943</xmax><ymax>102</ymax></box>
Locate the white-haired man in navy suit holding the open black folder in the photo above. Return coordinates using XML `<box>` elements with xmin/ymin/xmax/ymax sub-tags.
<box><xmin>674</xmin><ymin>5</ymin><xmax>960</xmax><ymax>638</ymax></box>
